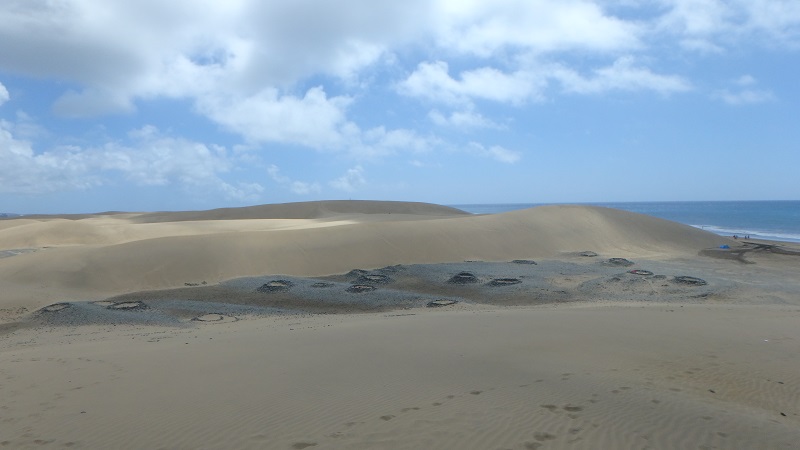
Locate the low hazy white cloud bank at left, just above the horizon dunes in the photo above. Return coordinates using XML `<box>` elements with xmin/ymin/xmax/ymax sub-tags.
<box><xmin>0</xmin><ymin>121</ymin><xmax>263</xmax><ymax>201</ymax></box>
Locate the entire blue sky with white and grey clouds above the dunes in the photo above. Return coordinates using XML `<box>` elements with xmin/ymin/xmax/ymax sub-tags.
<box><xmin>0</xmin><ymin>0</ymin><xmax>800</xmax><ymax>214</ymax></box>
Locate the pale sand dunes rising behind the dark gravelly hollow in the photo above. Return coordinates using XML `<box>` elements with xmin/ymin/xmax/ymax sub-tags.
<box><xmin>0</xmin><ymin>202</ymin><xmax>728</xmax><ymax>308</ymax></box>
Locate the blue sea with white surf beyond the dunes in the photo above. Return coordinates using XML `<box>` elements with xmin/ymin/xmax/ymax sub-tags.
<box><xmin>450</xmin><ymin>200</ymin><xmax>800</xmax><ymax>242</ymax></box>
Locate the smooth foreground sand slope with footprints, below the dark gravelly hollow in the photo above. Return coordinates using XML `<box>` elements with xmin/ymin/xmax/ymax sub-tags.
<box><xmin>0</xmin><ymin>304</ymin><xmax>800</xmax><ymax>449</ymax></box>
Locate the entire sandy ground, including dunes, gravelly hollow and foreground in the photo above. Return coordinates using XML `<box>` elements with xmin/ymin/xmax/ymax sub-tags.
<box><xmin>0</xmin><ymin>202</ymin><xmax>800</xmax><ymax>449</ymax></box>
